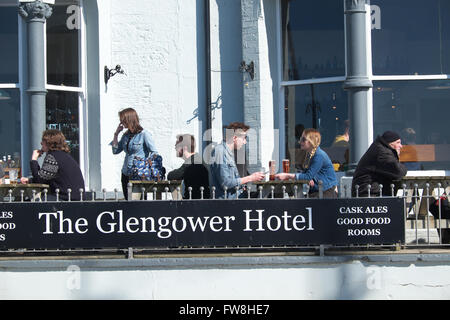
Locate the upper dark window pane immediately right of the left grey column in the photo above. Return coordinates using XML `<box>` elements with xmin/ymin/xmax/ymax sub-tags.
<box><xmin>47</xmin><ymin>0</ymin><xmax>80</xmax><ymax>87</ymax></box>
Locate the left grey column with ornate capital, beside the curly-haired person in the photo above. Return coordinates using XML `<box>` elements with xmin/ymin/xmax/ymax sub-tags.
<box><xmin>19</xmin><ymin>0</ymin><xmax>52</xmax><ymax>150</ymax></box>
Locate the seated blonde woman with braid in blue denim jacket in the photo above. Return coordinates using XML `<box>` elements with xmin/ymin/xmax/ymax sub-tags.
<box><xmin>275</xmin><ymin>128</ymin><xmax>337</xmax><ymax>198</ymax></box>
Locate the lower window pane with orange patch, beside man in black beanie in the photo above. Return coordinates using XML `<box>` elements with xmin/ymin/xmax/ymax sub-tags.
<box><xmin>373</xmin><ymin>80</ymin><xmax>450</xmax><ymax>170</ymax></box>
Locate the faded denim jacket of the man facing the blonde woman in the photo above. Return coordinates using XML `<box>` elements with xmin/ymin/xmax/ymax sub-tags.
<box><xmin>209</xmin><ymin>142</ymin><xmax>242</xmax><ymax>199</ymax></box>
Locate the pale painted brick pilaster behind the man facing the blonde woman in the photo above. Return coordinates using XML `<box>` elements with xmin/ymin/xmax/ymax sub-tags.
<box><xmin>241</xmin><ymin>0</ymin><xmax>279</xmax><ymax>172</ymax></box>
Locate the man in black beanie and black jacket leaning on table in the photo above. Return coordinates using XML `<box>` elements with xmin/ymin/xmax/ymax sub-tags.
<box><xmin>352</xmin><ymin>131</ymin><xmax>407</xmax><ymax>197</ymax></box>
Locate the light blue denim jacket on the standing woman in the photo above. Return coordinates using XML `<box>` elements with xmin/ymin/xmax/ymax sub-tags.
<box><xmin>110</xmin><ymin>130</ymin><xmax>158</xmax><ymax>176</ymax></box>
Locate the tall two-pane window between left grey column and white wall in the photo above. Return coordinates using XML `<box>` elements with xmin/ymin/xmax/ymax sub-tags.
<box><xmin>46</xmin><ymin>0</ymin><xmax>84</xmax><ymax>163</ymax></box>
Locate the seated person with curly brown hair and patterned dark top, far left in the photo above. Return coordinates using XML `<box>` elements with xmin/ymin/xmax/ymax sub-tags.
<box><xmin>21</xmin><ymin>130</ymin><xmax>84</xmax><ymax>201</ymax></box>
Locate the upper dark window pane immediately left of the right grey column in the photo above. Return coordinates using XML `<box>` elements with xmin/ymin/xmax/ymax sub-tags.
<box><xmin>281</xmin><ymin>0</ymin><xmax>345</xmax><ymax>80</ymax></box>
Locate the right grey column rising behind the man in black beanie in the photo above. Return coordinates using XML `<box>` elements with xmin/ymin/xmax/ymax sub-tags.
<box><xmin>344</xmin><ymin>0</ymin><xmax>373</xmax><ymax>170</ymax></box>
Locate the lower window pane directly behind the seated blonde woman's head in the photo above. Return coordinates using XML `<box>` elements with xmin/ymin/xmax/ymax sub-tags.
<box><xmin>285</xmin><ymin>82</ymin><xmax>349</xmax><ymax>170</ymax></box>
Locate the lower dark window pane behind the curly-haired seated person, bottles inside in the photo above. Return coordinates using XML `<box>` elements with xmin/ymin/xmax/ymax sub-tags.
<box><xmin>46</xmin><ymin>90</ymin><xmax>80</xmax><ymax>162</ymax></box>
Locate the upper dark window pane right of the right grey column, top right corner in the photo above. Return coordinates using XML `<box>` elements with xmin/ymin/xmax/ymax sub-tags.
<box><xmin>371</xmin><ymin>0</ymin><xmax>450</xmax><ymax>75</ymax></box>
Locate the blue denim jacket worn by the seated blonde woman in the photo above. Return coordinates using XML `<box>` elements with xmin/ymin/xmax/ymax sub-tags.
<box><xmin>295</xmin><ymin>147</ymin><xmax>337</xmax><ymax>192</ymax></box>
